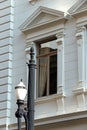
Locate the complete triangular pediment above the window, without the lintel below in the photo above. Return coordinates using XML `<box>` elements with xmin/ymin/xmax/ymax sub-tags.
<box><xmin>20</xmin><ymin>6</ymin><xmax>64</xmax><ymax>32</ymax></box>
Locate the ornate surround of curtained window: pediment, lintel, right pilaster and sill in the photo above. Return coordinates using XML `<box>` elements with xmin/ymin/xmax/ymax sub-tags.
<box><xmin>20</xmin><ymin>6</ymin><xmax>66</xmax><ymax>115</ymax></box>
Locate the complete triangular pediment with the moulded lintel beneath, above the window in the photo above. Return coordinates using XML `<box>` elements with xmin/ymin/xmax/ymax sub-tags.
<box><xmin>20</xmin><ymin>6</ymin><xmax>66</xmax><ymax>48</ymax></box>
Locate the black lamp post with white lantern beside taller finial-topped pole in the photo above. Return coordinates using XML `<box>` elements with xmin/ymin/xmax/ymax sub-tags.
<box><xmin>15</xmin><ymin>47</ymin><xmax>36</xmax><ymax>130</ymax></box>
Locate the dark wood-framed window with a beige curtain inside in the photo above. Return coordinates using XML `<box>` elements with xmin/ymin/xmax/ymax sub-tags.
<box><xmin>37</xmin><ymin>39</ymin><xmax>57</xmax><ymax>97</ymax></box>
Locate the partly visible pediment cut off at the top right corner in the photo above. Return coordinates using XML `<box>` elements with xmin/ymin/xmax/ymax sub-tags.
<box><xmin>68</xmin><ymin>0</ymin><xmax>87</xmax><ymax>15</ymax></box>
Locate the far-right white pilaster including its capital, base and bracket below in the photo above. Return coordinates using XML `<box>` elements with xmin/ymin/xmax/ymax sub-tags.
<box><xmin>73</xmin><ymin>26</ymin><xmax>87</xmax><ymax>110</ymax></box>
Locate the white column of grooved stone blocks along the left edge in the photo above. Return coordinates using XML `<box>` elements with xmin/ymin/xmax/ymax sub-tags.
<box><xmin>0</xmin><ymin>0</ymin><xmax>14</xmax><ymax>130</ymax></box>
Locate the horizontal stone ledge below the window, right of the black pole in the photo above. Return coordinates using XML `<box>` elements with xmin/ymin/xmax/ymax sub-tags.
<box><xmin>35</xmin><ymin>111</ymin><xmax>87</xmax><ymax>126</ymax></box>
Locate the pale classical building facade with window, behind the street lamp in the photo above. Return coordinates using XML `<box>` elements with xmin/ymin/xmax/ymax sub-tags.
<box><xmin>0</xmin><ymin>0</ymin><xmax>87</xmax><ymax>130</ymax></box>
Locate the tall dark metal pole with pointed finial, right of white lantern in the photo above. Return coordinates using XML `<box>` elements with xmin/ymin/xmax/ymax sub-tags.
<box><xmin>27</xmin><ymin>47</ymin><xmax>36</xmax><ymax>130</ymax></box>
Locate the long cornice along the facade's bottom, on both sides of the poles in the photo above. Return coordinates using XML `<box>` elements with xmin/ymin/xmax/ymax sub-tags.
<box><xmin>8</xmin><ymin>110</ymin><xmax>87</xmax><ymax>130</ymax></box>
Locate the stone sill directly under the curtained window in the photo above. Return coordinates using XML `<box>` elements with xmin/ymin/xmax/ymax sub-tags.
<box><xmin>35</xmin><ymin>93</ymin><xmax>65</xmax><ymax>105</ymax></box>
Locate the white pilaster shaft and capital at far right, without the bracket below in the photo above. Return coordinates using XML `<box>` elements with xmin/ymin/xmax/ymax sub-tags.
<box><xmin>76</xmin><ymin>27</ymin><xmax>85</xmax><ymax>87</ymax></box>
